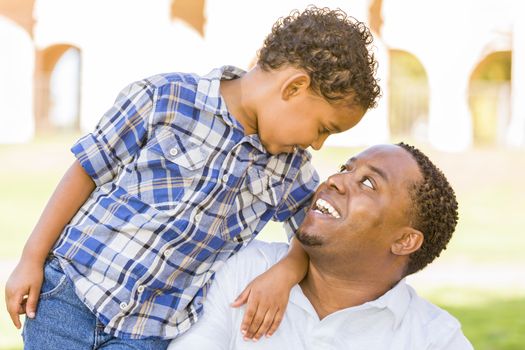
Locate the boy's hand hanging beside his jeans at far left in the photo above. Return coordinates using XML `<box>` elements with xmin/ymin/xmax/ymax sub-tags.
<box><xmin>5</xmin><ymin>261</ymin><xmax>44</xmax><ymax>329</ymax></box>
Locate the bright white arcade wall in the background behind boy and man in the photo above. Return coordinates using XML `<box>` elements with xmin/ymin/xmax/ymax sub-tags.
<box><xmin>0</xmin><ymin>0</ymin><xmax>525</xmax><ymax>150</ymax></box>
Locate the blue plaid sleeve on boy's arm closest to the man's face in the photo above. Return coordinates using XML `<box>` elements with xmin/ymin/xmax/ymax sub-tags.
<box><xmin>273</xmin><ymin>159</ymin><xmax>319</xmax><ymax>240</ymax></box>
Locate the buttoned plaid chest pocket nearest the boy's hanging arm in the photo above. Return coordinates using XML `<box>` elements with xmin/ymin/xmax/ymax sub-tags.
<box><xmin>125</xmin><ymin>131</ymin><xmax>208</xmax><ymax>210</ymax></box>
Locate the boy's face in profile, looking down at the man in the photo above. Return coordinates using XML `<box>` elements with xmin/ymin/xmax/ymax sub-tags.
<box><xmin>257</xmin><ymin>89</ymin><xmax>365</xmax><ymax>154</ymax></box>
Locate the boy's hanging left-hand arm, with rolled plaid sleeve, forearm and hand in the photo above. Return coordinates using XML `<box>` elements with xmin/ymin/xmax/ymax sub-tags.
<box><xmin>5</xmin><ymin>80</ymin><xmax>157</xmax><ymax>328</ymax></box>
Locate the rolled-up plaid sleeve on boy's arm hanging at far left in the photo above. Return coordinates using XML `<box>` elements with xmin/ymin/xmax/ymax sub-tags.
<box><xmin>71</xmin><ymin>80</ymin><xmax>155</xmax><ymax>186</ymax></box>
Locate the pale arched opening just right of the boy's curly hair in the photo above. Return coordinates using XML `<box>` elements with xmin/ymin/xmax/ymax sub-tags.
<box><xmin>389</xmin><ymin>50</ymin><xmax>429</xmax><ymax>139</ymax></box>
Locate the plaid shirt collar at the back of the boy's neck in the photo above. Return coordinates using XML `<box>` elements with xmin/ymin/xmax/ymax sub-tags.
<box><xmin>195</xmin><ymin>66</ymin><xmax>246</xmax><ymax>119</ymax></box>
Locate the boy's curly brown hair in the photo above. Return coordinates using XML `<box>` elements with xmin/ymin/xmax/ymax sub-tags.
<box><xmin>257</xmin><ymin>6</ymin><xmax>380</xmax><ymax>110</ymax></box>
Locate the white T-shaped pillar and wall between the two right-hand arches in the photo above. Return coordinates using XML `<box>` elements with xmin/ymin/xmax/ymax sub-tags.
<box><xmin>383</xmin><ymin>0</ymin><xmax>525</xmax><ymax>151</ymax></box>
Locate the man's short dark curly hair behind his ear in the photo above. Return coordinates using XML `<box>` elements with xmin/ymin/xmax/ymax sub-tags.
<box><xmin>397</xmin><ymin>142</ymin><xmax>458</xmax><ymax>275</ymax></box>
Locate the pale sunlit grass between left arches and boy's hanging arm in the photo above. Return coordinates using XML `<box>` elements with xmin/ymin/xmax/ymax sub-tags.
<box><xmin>0</xmin><ymin>135</ymin><xmax>76</xmax><ymax>260</ymax></box>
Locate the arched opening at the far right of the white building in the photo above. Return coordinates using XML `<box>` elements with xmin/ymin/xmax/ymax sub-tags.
<box><xmin>469</xmin><ymin>51</ymin><xmax>512</xmax><ymax>146</ymax></box>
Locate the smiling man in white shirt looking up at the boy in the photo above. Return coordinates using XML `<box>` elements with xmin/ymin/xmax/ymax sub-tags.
<box><xmin>169</xmin><ymin>143</ymin><xmax>472</xmax><ymax>350</ymax></box>
